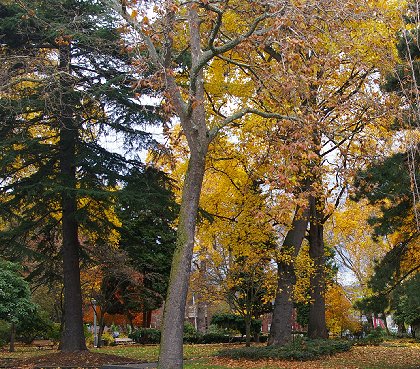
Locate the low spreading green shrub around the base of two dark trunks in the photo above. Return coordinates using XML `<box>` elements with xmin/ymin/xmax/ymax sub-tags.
<box><xmin>218</xmin><ymin>339</ymin><xmax>351</xmax><ymax>361</ymax></box>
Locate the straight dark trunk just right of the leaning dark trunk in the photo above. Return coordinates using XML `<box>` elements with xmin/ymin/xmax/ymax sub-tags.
<box><xmin>308</xmin><ymin>196</ymin><xmax>328</xmax><ymax>338</ymax></box>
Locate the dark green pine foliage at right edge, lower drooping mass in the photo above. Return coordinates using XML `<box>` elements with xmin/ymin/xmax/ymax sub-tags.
<box><xmin>355</xmin><ymin>151</ymin><xmax>420</xmax><ymax>328</ymax></box>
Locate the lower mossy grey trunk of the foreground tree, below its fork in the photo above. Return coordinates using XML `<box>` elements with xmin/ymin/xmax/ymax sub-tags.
<box><xmin>158</xmin><ymin>147</ymin><xmax>207</xmax><ymax>369</ymax></box>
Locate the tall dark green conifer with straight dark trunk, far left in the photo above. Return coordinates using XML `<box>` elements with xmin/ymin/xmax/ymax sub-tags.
<box><xmin>0</xmin><ymin>0</ymin><xmax>159</xmax><ymax>351</ymax></box>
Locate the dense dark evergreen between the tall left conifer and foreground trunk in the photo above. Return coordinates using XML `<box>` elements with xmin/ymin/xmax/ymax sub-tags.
<box><xmin>118</xmin><ymin>167</ymin><xmax>178</xmax><ymax>312</ymax></box>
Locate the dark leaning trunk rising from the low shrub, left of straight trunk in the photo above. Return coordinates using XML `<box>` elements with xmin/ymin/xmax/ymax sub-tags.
<box><xmin>268</xmin><ymin>209</ymin><xmax>309</xmax><ymax>346</ymax></box>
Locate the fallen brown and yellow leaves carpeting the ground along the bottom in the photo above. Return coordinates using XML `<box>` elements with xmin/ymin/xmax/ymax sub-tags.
<box><xmin>0</xmin><ymin>341</ymin><xmax>420</xmax><ymax>369</ymax></box>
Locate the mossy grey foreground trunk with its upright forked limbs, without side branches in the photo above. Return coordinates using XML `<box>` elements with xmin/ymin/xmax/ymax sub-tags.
<box><xmin>158</xmin><ymin>5</ymin><xmax>210</xmax><ymax>369</ymax></box>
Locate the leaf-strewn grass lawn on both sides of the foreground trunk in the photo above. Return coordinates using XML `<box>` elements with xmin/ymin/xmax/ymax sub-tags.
<box><xmin>0</xmin><ymin>340</ymin><xmax>420</xmax><ymax>369</ymax></box>
